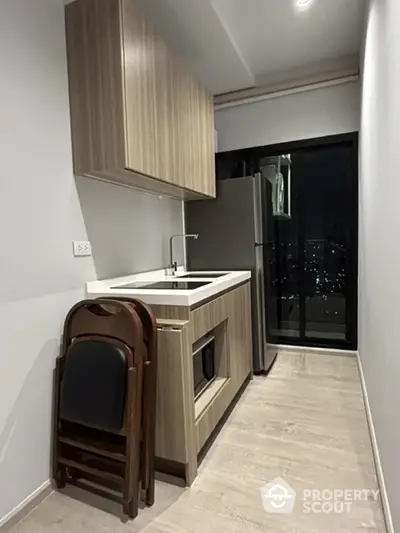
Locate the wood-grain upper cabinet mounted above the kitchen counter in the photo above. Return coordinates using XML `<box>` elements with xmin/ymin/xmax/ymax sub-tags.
<box><xmin>66</xmin><ymin>0</ymin><xmax>215</xmax><ymax>199</ymax></box>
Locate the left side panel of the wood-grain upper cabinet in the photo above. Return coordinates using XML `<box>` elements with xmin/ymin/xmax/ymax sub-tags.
<box><xmin>65</xmin><ymin>0</ymin><xmax>125</xmax><ymax>175</ymax></box>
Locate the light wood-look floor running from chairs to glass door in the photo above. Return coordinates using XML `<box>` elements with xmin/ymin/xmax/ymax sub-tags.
<box><xmin>12</xmin><ymin>353</ymin><xmax>385</xmax><ymax>533</ymax></box>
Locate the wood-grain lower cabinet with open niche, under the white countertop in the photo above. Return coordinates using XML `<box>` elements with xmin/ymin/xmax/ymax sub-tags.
<box><xmin>152</xmin><ymin>283</ymin><xmax>252</xmax><ymax>485</ymax></box>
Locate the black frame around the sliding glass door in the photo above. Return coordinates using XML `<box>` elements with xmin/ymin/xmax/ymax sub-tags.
<box><xmin>217</xmin><ymin>132</ymin><xmax>359</xmax><ymax>350</ymax></box>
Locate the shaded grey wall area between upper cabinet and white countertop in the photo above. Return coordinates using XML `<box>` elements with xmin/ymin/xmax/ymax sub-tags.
<box><xmin>76</xmin><ymin>177</ymin><xmax>184</xmax><ymax>279</ymax></box>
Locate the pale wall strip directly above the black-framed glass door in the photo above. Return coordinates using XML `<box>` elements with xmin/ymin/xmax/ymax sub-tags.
<box><xmin>215</xmin><ymin>82</ymin><xmax>360</xmax><ymax>152</ymax></box>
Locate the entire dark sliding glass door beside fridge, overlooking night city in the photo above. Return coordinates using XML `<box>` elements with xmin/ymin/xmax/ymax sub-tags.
<box><xmin>260</xmin><ymin>136</ymin><xmax>357</xmax><ymax>348</ymax></box>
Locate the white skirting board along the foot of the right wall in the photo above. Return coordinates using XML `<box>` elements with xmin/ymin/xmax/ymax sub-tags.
<box><xmin>357</xmin><ymin>354</ymin><xmax>395</xmax><ymax>533</ymax></box>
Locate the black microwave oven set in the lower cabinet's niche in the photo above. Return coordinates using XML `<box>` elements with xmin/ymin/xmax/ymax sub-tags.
<box><xmin>193</xmin><ymin>335</ymin><xmax>216</xmax><ymax>399</ymax></box>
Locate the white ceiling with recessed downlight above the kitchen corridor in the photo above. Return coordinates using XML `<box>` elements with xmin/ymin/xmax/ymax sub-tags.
<box><xmin>139</xmin><ymin>0</ymin><xmax>365</xmax><ymax>94</ymax></box>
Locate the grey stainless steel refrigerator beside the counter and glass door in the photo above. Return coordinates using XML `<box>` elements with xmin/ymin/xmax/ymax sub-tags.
<box><xmin>185</xmin><ymin>174</ymin><xmax>276</xmax><ymax>373</ymax></box>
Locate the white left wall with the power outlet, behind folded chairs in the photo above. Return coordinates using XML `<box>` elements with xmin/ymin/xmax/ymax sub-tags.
<box><xmin>0</xmin><ymin>0</ymin><xmax>182</xmax><ymax>524</ymax></box>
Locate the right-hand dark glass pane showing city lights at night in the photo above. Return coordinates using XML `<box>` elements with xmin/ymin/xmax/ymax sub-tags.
<box><xmin>294</xmin><ymin>145</ymin><xmax>354</xmax><ymax>342</ymax></box>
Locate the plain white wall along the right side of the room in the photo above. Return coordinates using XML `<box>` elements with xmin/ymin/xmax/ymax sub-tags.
<box><xmin>359</xmin><ymin>0</ymin><xmax>400</xmax><ymax>531</ymax></box>
